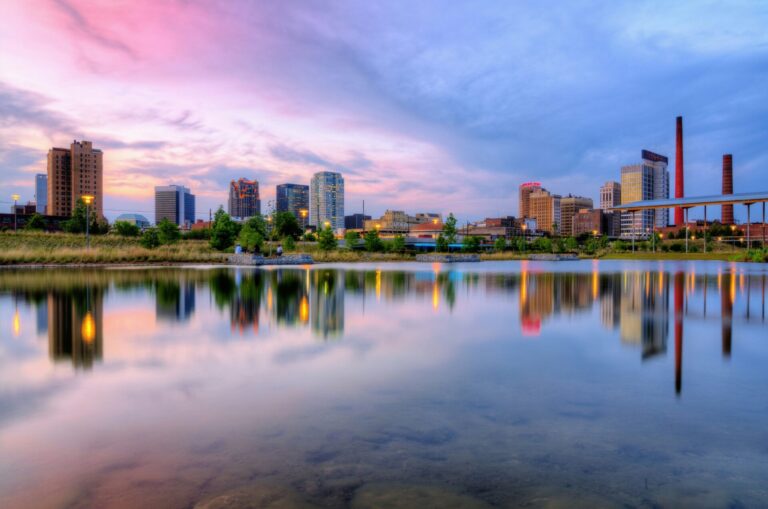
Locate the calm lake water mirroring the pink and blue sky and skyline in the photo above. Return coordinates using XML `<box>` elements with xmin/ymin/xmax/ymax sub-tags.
<box><xmin>0</xmin><ymin>262</ymin><xmax>768</xmax><ymax>508</ymax></box>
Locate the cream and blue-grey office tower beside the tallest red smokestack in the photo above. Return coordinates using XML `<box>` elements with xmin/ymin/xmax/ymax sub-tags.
<box><xmin>621</xmin><ymin>150</ymin><xmax>669</xmax><ymax>238</ymax></box>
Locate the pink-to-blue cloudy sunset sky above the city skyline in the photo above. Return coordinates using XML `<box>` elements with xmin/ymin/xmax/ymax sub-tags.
<box><xmin>0</xmin><ymin>0</ymin><xmax>768</xmax><ymax>220</ymax></box>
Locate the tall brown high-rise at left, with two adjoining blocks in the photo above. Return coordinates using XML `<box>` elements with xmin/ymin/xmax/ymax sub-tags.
<box><xmin>46</xmin><ymin>140</ymin><xmax>104</xmax><ymax>217</ymax></box>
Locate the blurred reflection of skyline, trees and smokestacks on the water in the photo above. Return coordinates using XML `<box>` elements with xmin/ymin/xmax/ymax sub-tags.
<box><xmin>0</xmin><ymin>263</ymin><xmax>766</xmax><ymax>382</ymax></box>
